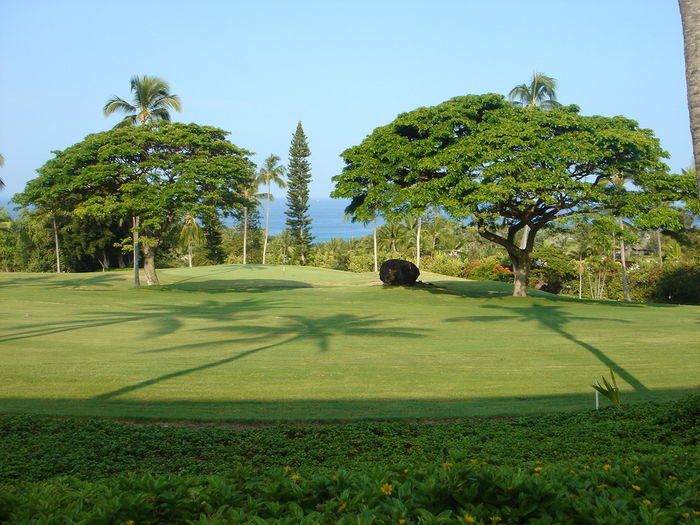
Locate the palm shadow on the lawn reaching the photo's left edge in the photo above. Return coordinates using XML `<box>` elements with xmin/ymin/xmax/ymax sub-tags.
<box><xmin>0</xmin><ymin>297</ymin><xmax>289</xmax><ymax>343</ymax></box>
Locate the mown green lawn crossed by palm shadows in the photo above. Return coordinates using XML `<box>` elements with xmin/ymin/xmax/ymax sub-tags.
<box><xmin>0</xmin><ymin>265</ymin><xmax>700</xmax><ymax>421</ymax></box>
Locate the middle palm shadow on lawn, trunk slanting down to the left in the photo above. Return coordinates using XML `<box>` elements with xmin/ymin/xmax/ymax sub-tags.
<box><xmin>93</xmin><ymin>314</ymin><xmax>428</xmax><ymax>400</ymax></box>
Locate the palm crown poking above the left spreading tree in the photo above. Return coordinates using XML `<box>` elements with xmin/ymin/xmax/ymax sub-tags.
<box><xmin>103</xmin><ymin>75</ymin><xmax>182</xmax><ymax>128</ymax></box>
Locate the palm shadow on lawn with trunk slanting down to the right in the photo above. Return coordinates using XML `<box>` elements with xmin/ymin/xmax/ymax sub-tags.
<box><xmin>446</xmin><ymin>303</ymin><xmax>648</xmax><ymax>392</ymax></box>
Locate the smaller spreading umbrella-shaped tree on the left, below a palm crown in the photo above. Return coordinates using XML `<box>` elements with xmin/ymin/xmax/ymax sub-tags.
<box><xmin>15</xmin><ymin>122</ymin><xmax>255</xmax><ymax>285</ymax></box>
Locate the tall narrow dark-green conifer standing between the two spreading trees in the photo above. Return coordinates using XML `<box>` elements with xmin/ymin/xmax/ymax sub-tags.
<box><xmin>285</xmin><ymin>122</ymin><xmax>314</xmax><ymax>264</ymax></box>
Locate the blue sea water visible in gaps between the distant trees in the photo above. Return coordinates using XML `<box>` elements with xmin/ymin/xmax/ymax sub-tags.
<box><xmin>0</xmin><ymin>196</ymin><xmax>372</xmax><ymax>242</ymax></box>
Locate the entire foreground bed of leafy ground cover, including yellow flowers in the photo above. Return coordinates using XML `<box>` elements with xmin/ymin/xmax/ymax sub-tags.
<box><xmin>0</xmin><ymin>396</ymin><xmax>700</xmax><ymax>524</ymax></box>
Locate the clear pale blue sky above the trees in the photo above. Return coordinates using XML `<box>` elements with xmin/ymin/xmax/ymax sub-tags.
<box><xmin>0</xmin><ymin>0</ymin><xmax>692</xmax><ymax>199</ymax></box>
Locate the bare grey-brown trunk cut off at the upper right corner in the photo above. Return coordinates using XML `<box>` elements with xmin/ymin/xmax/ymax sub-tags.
<box><xmin>678</xmin><ymin>0</ymin><xmax>700</xmax><ymax>195</ymax></box>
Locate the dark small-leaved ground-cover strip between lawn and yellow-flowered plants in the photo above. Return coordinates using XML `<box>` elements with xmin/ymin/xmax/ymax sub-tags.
<box><xmin>0</xmin><ymin>396</ymin><xmax>700</xmax><ymax>481</ymax></box>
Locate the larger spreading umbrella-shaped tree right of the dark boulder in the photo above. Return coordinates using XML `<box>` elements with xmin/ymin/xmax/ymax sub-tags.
<box><xmin>331</xmin><ymin>94</ymin><xmax>679</xmax><ymax>296</ymax></box>
